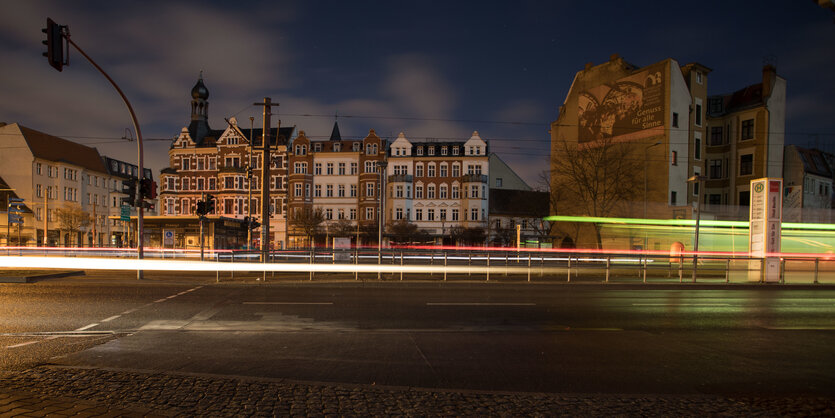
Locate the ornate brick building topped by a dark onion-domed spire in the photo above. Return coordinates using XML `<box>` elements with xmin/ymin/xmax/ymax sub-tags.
<box><xmin>160</xmin><ymin>72</ymin><xmax>295</xmax><ymax>248</ymax></box>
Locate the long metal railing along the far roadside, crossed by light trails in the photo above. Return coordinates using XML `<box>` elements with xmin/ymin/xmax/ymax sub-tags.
<box><xmin>0</xmin><ymin>247</ymin><xmax>835</xmax><ymax>284</ymax></box>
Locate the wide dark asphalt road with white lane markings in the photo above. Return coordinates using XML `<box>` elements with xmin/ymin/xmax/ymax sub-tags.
<box><xmin>0</xmin><ymin>280</ymin><xmax>835</xmax><ymax>396</ymax></box>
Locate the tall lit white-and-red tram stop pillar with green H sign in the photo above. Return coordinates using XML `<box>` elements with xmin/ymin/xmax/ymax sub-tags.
<box><xmin>748</xmin><ymin>178</ymin><xmax>783</xmax><ymax>283</ymax></box>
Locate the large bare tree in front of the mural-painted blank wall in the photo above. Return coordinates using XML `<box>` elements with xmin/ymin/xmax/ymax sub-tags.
<box><xmin>551</xmin><ymin>138</ymin><xmax>643</xmax><ymax>248</ymax></box>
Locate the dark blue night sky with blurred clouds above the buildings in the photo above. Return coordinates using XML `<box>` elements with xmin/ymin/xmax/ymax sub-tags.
<box><xmin>0</xmin><ymin>0</ymin><xmax>835</xmax><ymax>186</ymax></box>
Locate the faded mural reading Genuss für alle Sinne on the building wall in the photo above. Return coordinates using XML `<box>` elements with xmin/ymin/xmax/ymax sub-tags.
<box><xmin>578</xmin><ymin>64</ymin><xmax>666</xmax><ymax>143</ymax></box>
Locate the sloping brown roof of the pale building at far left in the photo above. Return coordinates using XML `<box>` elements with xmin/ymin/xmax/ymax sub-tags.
<box><xmin>15</xmin><ymin>124</ymin><xmax>107</xmax><ymax>173</ymax></box>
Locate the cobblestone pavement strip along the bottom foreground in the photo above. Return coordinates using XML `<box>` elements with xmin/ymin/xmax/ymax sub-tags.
<box><xmin>0</xmin><ymin>366</ymin><xmax>835</xmax><ymax>416</ymax></box>
